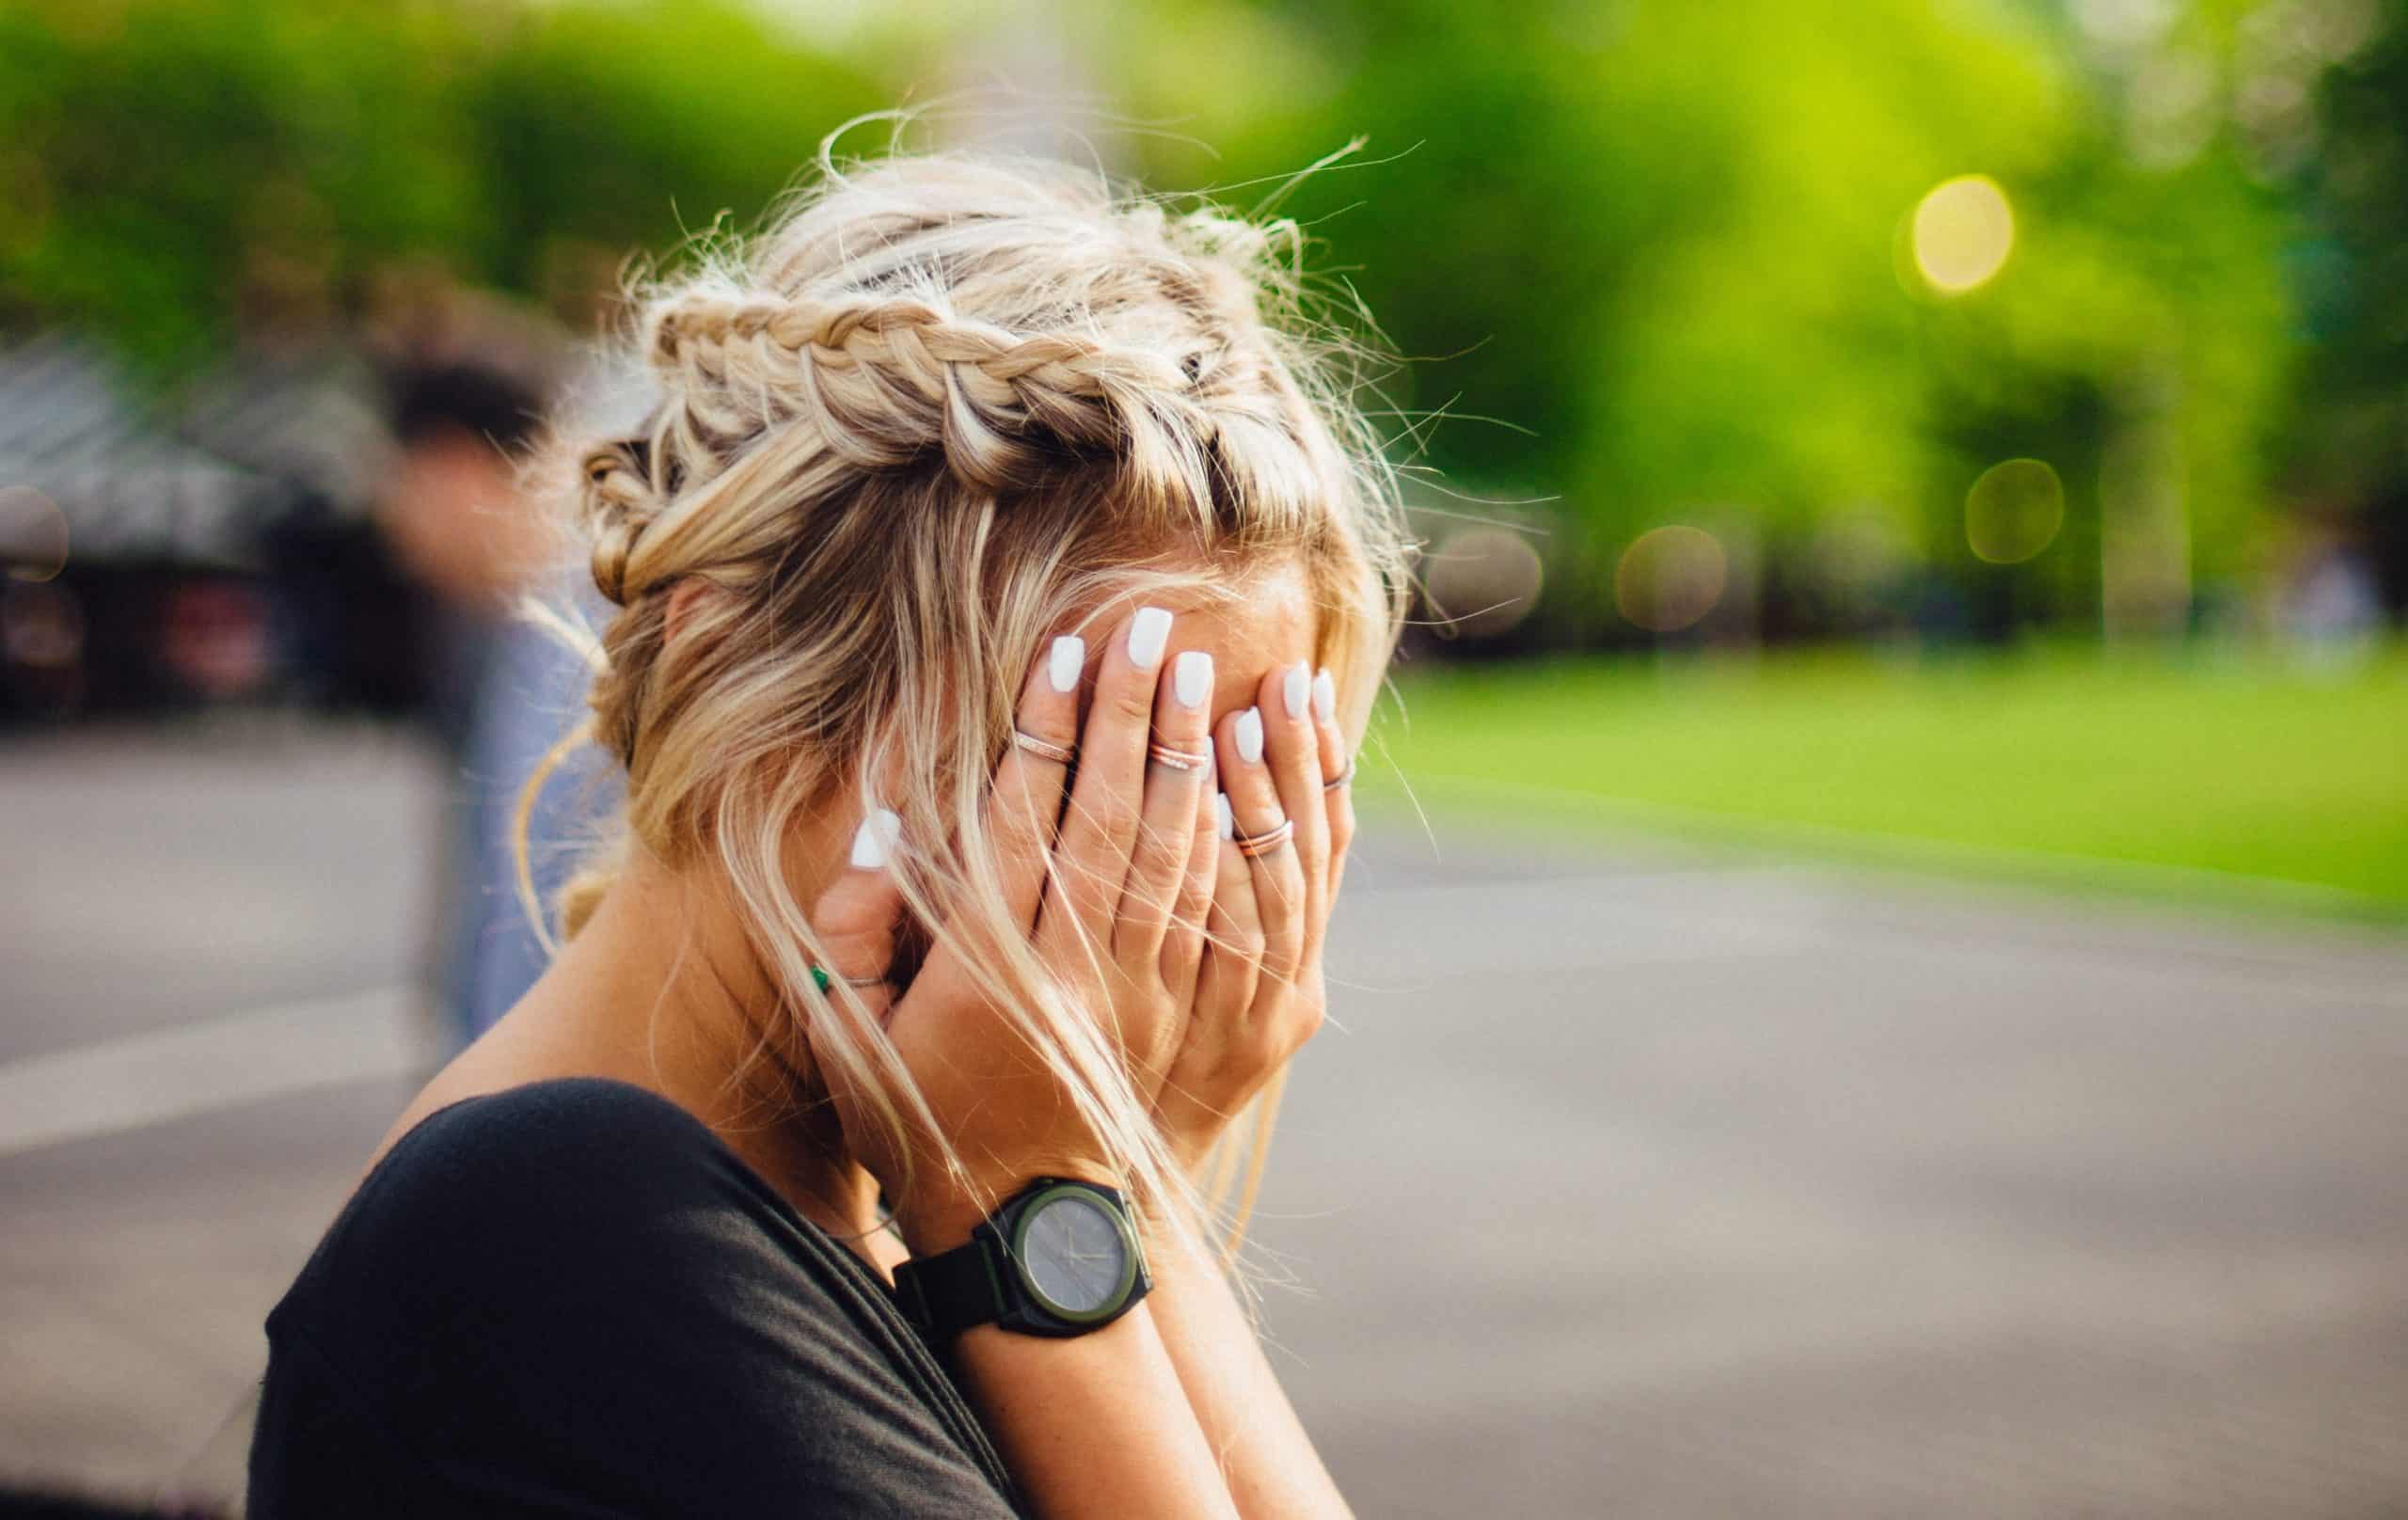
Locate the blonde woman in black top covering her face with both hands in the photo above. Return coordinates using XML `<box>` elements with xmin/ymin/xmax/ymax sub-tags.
<box><xmin>250</xmin><ymin>136</ymin><xmax>1409</xmax><ymax>1517</ymax></box>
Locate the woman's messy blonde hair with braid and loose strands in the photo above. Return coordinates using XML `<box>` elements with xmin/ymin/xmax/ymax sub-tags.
<box><xmin>515</xmin><ymin>124</ymin><xmax>1414</xmax><ymax>1300</ymax></box>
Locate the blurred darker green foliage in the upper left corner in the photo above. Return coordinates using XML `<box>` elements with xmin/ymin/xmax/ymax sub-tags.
<box><xmin>0</xmin><ymin>0</ymin><xmax>884</xmax><ymax>376</ymax></box>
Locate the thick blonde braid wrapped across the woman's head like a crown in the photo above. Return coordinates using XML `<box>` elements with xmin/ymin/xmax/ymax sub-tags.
<box><xmin>583</xmin><ymin>229</ymin><xmax>1317</xmax><ymax>605</ymax></box>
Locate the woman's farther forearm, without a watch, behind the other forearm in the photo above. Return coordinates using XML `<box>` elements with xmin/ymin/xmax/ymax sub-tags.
<box><xmin>1144</xmin><ymin>1190</ymin><xmax>1354</xmax><ymax>1520</ymax></box>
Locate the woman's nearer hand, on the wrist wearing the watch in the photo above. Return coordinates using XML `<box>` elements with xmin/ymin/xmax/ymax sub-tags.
<box><xmin>812</xmin><ymin>607</ymin><xmax>1218</xmax><ymax>1253</ymax></box>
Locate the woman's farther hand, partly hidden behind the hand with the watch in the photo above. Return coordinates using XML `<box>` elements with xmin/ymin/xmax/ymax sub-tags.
<box><xmin>1153</xmin><ymin>662</ymin><xmax>1355</xmax><ymax>1176</ymax></box>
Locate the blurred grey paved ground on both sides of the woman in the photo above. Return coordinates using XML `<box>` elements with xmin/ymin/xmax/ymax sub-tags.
<box><xmin>0</xmin><ymin>727</ymin><xmax>2408</xmax><ymax>1517</ymax></box>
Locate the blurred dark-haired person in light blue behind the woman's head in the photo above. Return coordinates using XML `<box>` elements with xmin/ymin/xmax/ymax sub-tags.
<box><xmin>375</xmin><ymin>356</ymin><xmax>611</xmax><ymax>1048</ymax></box>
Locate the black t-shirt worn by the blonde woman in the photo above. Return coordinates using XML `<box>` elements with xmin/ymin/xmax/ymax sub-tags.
<box><xmin>250</xmin><ymin>1077</ymin><xmax>1019</xmax><ymax>1520</ymax></box>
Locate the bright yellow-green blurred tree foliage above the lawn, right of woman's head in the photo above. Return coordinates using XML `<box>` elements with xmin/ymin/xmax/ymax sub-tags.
<box><xmin>1088</xmin><ymin>0</ymin><xmax>2295</xmax><ymax>634</ymax></box>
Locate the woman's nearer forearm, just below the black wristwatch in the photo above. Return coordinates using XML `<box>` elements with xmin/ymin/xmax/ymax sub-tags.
<box><xmin>954</xmin><ymin>1296</ymin><xmax>1238</xmax><ymax>1520</ymax></box>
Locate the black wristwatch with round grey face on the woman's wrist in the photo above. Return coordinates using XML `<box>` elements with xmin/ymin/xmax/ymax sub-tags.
<box><xmin>895</xmin><ymin>1178</ymin><xmax>1153</xmax><ymax>1347</ymax></box>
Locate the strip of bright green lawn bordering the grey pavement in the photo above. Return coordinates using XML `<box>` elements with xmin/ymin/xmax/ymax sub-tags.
<box><xmin>1363</xmin><ymin>645</ymin><xmax>2408</xmax><ymax>920</ymax></box>
